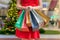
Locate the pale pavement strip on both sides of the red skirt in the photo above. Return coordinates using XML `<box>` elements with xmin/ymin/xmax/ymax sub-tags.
<box><xmin>0</xmin><ymin>34</ymin><xmax>60</xmax><ymax>40</ymax></box>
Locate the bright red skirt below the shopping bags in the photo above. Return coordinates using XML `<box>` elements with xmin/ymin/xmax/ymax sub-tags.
<box><xmin>16</xmin><ymin>28</ymin><xmax>40</xmax><ymax>39</ymax></box>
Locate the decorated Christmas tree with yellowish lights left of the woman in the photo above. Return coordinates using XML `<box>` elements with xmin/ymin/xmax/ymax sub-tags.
<box><xmin>2</xmin><ymin>0</ymin><xmax>18</xmax><ymax>34</ymax></box>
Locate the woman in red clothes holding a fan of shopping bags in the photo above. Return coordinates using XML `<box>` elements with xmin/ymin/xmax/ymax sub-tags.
<box><xmin>16</xmin><ymin>0</ymin><xmax>42</xmax><ymax>40</ymax></box>
